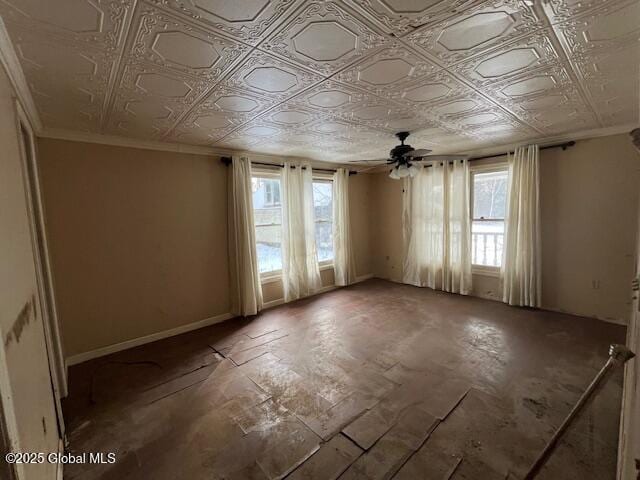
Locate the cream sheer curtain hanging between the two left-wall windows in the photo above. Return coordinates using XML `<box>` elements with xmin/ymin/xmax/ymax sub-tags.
<box><xmin>282</xmin><ymin>162</ymin><xmax>322</xmax><ymax>302</ymax></box>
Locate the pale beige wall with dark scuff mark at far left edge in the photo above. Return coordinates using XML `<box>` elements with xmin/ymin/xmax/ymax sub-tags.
<box><xmin>0</xmin><ymin>66</ymin><xmax>58</xmax><ymax>480</ymax></box>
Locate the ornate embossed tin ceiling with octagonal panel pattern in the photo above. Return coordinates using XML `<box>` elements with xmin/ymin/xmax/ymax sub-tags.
<box><xmin>0</xmin><ymin>0</ymin><xmax>640</xmax><ymax>162</ymax></box>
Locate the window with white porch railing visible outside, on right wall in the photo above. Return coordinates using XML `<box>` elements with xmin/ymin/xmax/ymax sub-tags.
<box><xmin>471</xmin><ymin>168</ymin><xmax>507</xmax><ymax>268</ymax></box>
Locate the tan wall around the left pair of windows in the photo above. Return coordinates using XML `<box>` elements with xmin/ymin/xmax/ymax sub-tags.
<box><xmin>39</xmin><ymin>139</ymin><xmax>371</xmax><ymax>357</ymax></box>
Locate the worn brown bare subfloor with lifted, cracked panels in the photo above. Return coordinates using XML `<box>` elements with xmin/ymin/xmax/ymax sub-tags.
<box><xmin>64</xmin><ymin>280</ymin><xmax>624</xmax><ymax>480</ymax></box>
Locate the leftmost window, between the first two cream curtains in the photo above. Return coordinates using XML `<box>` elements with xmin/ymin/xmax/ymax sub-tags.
<box><xmin>251</xmin><ymin>173</ymin><xmax>282</xmax><ymax>274</ymax></box>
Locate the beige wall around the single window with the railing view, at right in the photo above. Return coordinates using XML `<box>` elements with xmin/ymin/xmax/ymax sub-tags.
<box><xmin>371</xmin><ymin>135</ymin><xmax>640</xmax><ymax>322</ymax></box>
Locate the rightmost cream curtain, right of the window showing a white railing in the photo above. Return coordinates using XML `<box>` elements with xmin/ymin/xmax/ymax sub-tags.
<box><xmin>501</xmin><ymin>145</ymin><xmax>542</xmax><ymax>307</ymax></box>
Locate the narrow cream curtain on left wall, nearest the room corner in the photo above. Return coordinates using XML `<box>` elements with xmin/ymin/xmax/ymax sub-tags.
<box><xmin>333</xmin><ymin>168</ymin><xmax>356</xmax><ymax>286</ymax></box>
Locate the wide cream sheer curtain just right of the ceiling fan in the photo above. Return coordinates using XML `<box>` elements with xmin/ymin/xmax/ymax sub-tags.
<box><xmin>402</xmin><ymin>160</ymin><xmax>471</xmax><ymax>295</ymax></box>
